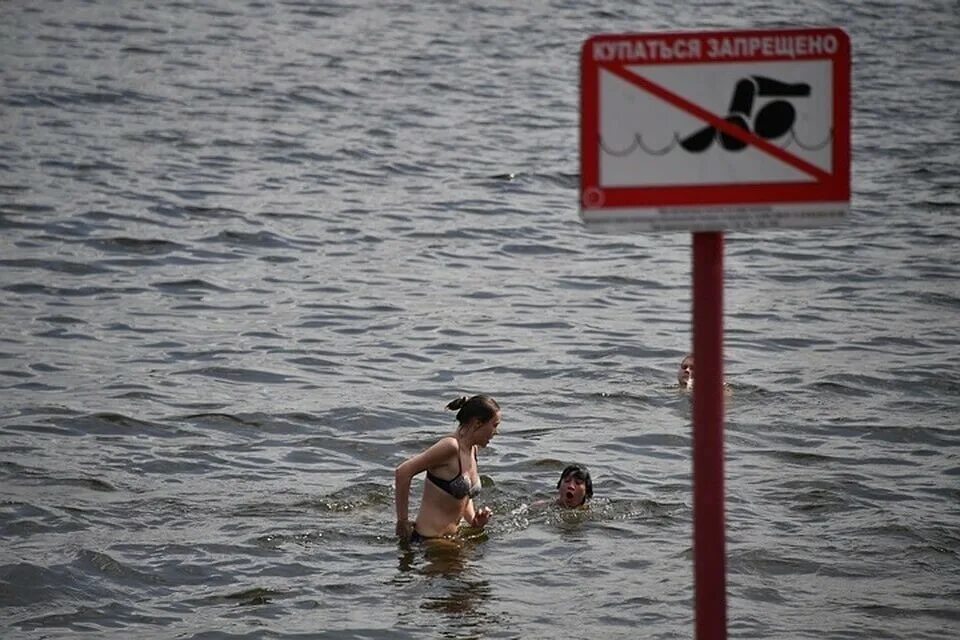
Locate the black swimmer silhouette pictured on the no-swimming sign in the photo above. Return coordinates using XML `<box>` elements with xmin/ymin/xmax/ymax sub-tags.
<box><xmin>680</xmin><ymin>76</ymin><xmax>810</xmax><ymax>153</ymax></box>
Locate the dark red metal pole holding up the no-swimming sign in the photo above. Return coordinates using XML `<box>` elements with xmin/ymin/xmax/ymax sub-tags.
<box><xmin>693</xmin><ymin>231</ymin><xmax>727</xmax><ymax>640</ymax></box>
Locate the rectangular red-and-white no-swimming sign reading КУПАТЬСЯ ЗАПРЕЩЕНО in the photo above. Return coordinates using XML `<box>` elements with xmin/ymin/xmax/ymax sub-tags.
<box><xmin>580</xmin><ymin>28</ymin><xmax>850</xmax><ymax>231</ymax></box>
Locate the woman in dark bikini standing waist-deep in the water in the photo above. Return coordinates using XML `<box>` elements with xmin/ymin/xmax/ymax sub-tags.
<box><xmin>394</xmin><ymin>395</ymin><xmax>500</xmax><ymax>542</ymax></box>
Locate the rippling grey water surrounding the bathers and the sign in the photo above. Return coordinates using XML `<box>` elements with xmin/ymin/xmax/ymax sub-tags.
<box><xmin>0</xmin><ymin>0</ymin><xmax>960</xmax><ymax>640</ymax></box>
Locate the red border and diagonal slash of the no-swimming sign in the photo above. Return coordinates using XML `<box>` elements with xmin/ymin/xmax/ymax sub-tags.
<box><xmin>580</xmin><ymin>27</ymin><xmax>850</xmax><ymax>212</ymax></box>
